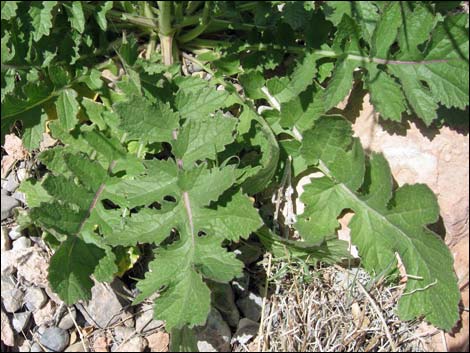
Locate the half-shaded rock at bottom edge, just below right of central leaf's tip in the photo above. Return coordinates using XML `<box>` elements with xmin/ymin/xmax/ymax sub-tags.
<box><xmin>196</xmin><ymin>308</ymin><xmax>232</xmax><ymax>352</ymax></box>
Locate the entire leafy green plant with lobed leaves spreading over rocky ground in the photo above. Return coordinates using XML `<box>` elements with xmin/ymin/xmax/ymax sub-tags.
<box><xmin>2</xmin><ymin>1</ymin><xmax>468</xmax><ymax>349</ymax></box>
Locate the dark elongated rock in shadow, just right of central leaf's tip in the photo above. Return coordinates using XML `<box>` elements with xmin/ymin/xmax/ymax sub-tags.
<box><xmin>209</xmin><ymin>282</ymin><xmax>240</xmax><ymax>327</ymax></box>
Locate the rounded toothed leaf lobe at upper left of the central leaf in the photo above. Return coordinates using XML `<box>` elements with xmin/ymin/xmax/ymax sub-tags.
<box><xmin>113</xmin><ymin>96</ymin><xmax>179</xmax><ymax>143</ymax></box>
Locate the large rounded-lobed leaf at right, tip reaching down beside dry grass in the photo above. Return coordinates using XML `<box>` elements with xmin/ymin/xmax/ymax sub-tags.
<box><xmin>298</xmin><ymin>117</ymin><xmax>460</xmax><ymax>330</ymax></box>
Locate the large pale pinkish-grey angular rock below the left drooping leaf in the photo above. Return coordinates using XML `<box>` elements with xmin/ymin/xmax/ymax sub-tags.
<box><xmin>77</xmin><ymin>279</ymin><xmax>129</xmax><ymax>328</ymax></box>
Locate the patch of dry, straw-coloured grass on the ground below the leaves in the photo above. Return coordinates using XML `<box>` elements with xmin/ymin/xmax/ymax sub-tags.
<box><xmin>241</xmin><ymin>262</ymin><xmax>432</xmax><ymax>352</ymax></box>
